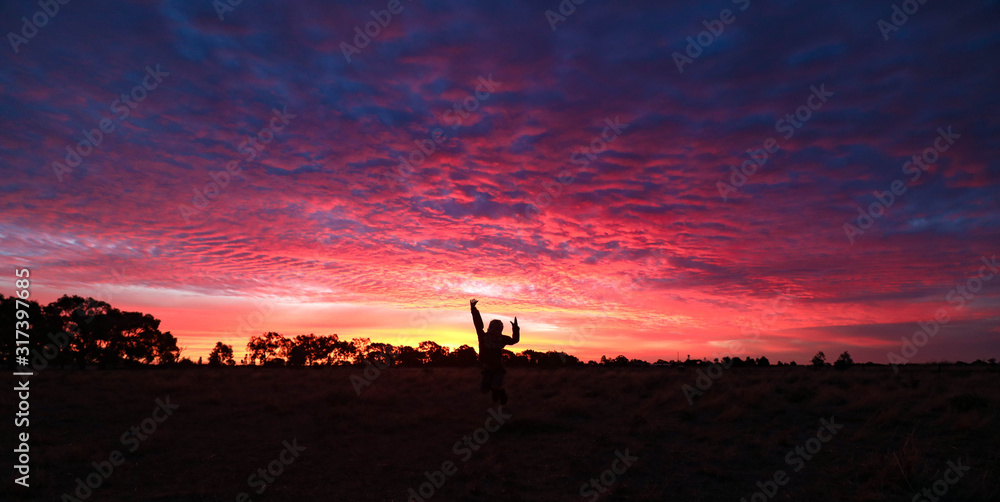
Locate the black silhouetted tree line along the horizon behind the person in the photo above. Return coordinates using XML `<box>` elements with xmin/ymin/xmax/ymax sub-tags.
<box><xmin>11</xmin><ymin>294</ymin><xmax>996</xmax><ymax>369</ymax></box>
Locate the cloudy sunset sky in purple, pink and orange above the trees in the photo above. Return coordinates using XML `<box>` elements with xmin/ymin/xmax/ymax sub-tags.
<box><xmin>0</xmin><ymin>0</ymin><xmax>1000</xmax><ymax>363</ymax></box>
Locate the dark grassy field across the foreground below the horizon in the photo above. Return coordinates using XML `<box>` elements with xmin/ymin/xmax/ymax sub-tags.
<box><xmin>0</xmin><ymin>366</ymin><xmax>1000</xmax><ymax>501</ymax></box>
